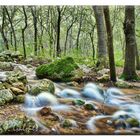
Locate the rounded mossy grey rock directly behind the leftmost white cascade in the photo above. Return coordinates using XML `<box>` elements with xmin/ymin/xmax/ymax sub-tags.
<box><xmin>29</xmin><ymin>79</ymin><xmax>55</xmax><ymax>95</ymax></box>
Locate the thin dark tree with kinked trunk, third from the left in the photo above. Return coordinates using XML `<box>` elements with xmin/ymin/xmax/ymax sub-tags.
<box><xmin>22</xmin><ymin>6</ymin><xmax>27</xmax><ymax>58</ymax></box>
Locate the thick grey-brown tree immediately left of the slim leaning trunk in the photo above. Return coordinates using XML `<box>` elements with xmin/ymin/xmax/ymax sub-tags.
<box><xmin>92</xmin><ymin>6</ymin><xmax>107</xmax><ymax>67</ymax></box>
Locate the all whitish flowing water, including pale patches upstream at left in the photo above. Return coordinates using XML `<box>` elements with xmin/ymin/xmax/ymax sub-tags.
<box><xmin>0</xmin><ymin>64</ymin><xmax>140</xmax><ymax>133</ymax></box>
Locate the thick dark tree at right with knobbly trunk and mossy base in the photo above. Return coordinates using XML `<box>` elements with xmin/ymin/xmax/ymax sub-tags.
<box><xmin>122</xmin><ymin>6</ymin><xmax>137</xmax><ymax>80</ymax></box>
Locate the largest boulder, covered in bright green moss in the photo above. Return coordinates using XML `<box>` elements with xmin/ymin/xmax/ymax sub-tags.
<box><xmin>36</xmin><ymin>57</ymin><xmax>78</xmax><ymax>81</ymax></box>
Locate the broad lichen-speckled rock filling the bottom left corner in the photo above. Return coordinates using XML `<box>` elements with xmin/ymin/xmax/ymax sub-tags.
<box><xmin>0</xmin><ymin>116</ymin><xmax>38</xmax><ymax>134</ymax></box>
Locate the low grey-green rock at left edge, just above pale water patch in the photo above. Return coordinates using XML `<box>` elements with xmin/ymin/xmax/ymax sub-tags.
<box><xmin>0</xmin><ymin>62</ymin><xmax>13</xmax><ymax>71</ymax></box>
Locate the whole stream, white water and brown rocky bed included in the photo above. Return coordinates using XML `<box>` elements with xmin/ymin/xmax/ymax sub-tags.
<box><xmin>0</xmin><ymin>63</ymin><xmax>140</xmax><ymax>134</ymax></box>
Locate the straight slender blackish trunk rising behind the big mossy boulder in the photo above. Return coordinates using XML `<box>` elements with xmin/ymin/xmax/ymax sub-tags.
<box><xmin>56</xmin><ymin>6</ymin><xmax>61</xmax><ymax>57</ymax></box>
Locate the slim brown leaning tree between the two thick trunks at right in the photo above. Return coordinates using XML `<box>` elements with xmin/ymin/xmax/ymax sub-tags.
<box><xmin>104</xmin><ymin>6</ymin><xmax>116</xmax><ymax>82</ymax></box>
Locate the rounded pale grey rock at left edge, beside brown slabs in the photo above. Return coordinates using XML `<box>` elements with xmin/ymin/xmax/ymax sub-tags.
<box><xmin>0</xmin><ymin>89</ymin><xmax>14</xmax><ymax>105</ymax></box>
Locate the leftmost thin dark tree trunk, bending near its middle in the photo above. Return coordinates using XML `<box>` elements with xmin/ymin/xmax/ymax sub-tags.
<box><xmin>0</xmin><ymin>7</ymin><xmax>9</xmax><ymax>50</ymax></box>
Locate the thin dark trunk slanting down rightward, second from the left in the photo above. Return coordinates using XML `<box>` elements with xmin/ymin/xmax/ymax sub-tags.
<box><xmin>4</xmin><ymin>6</ymin><xmax>17</xmax><ymax>51</ymax></box>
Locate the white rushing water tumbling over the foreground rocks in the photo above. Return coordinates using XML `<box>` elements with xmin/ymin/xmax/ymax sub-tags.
<box><xmin>21</xmin><ymin>80</ymin><xmax>140</xmax><ymax>132</ymax></box>
